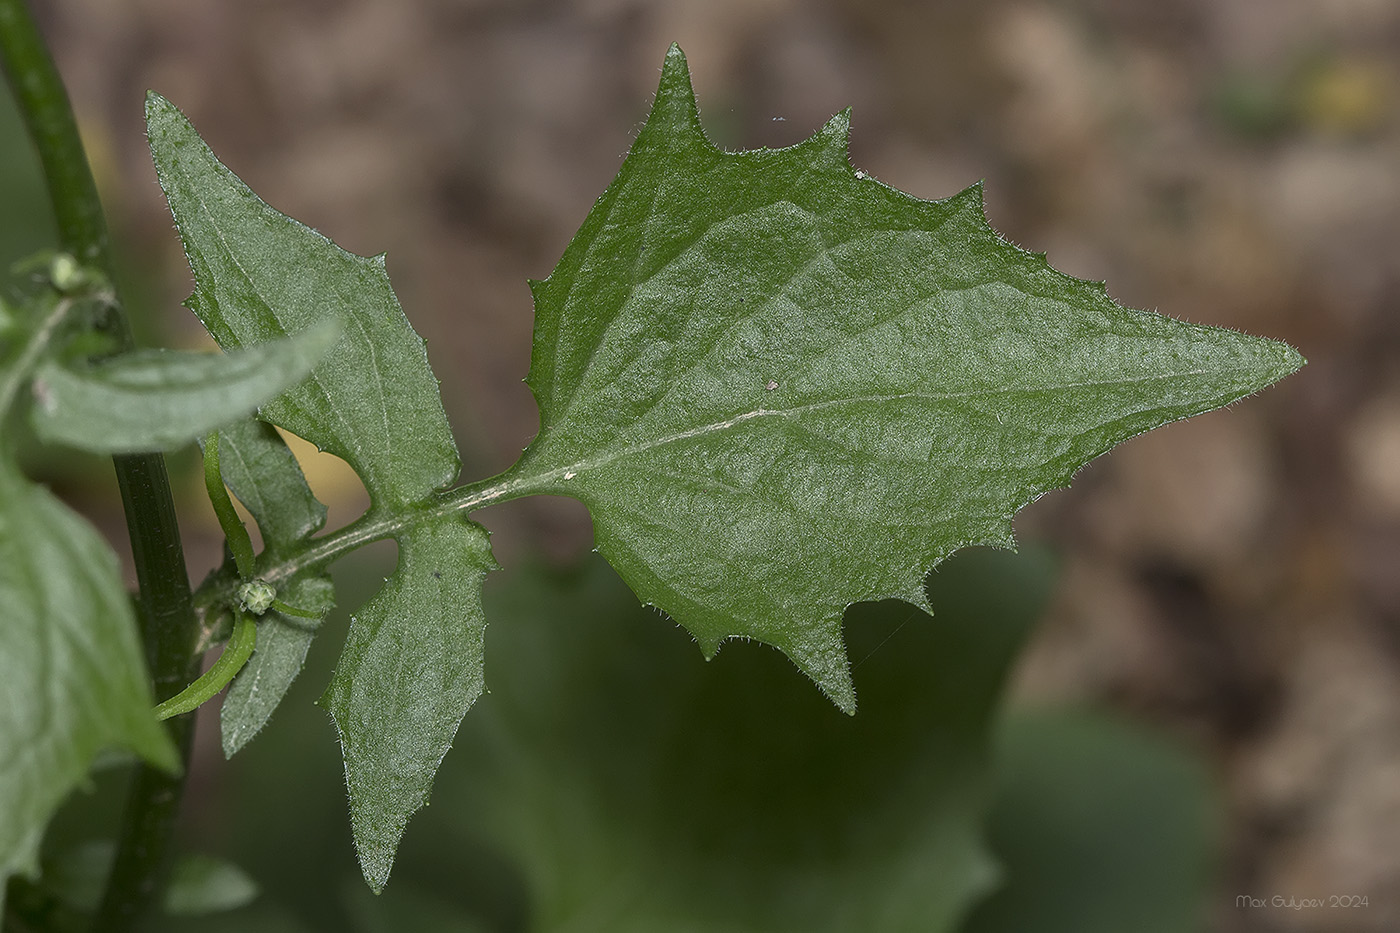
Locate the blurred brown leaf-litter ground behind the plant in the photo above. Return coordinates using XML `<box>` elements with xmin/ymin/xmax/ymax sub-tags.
<box><xmin>13</xmin><ymin>0</ymin><xmax>1400</xmax><ymax>932</ymax></box>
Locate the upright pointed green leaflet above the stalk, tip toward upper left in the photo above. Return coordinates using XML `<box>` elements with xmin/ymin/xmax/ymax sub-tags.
<box><xmin>146</xmin><ymin>94</ymin><xmax>461</xmax><ymax>506</ymax></box>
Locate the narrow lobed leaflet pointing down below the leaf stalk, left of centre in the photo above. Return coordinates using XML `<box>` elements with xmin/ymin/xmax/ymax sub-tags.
<box><xmin>321</xmin><ymin>516</ymin><xmax>496</xmax><ymax>891</ymax></box>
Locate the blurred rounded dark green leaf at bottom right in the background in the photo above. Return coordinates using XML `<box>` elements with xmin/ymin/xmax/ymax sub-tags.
<box><xmin>963</xmin><ymin>713</ymin><xmax>1218</xmax><ymax>933</ymax></box>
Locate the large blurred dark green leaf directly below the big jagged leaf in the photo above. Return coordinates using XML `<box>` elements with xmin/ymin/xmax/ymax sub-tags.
<box><xmin>436</xmin><ymin>551</ymin><xmax>1053</xmax><ymax>933</ymax></box>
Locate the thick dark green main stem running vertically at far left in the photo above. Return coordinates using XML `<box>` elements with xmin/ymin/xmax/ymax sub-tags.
<box><xmin>0</xmin><ymin>0</ymin><xmax>199</xmax><ymax>930</ymax></box>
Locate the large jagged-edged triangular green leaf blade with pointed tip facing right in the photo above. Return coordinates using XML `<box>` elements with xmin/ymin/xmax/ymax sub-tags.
<box><xmin>512</xmin><ymin>48</ymin><xmax>1302</xmax><ymax>710</ymax></box>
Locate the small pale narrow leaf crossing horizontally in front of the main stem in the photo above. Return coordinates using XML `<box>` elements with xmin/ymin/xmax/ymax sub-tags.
<box><xmin>29</xmin><ymin>322</ymin><xmax>339</xmax><ymax>454</ymax></box>
